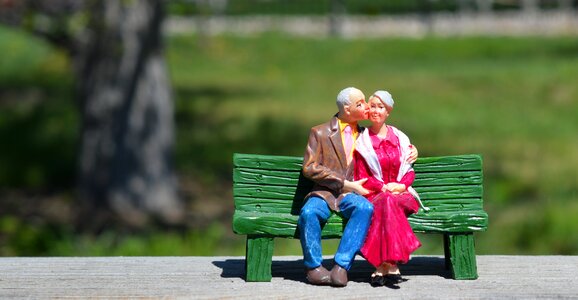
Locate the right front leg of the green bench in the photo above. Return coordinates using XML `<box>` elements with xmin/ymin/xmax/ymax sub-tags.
<box><xmin>444</xmin><ymin>233</ymin><xmax>478</xmax><ymax>279</ymax></box>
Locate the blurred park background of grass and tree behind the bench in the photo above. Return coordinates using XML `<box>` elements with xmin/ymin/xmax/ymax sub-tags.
<box><xmin>0</xmin><ymin>0</ymin><xmax>578</xmax><ymax>256</ymax></box>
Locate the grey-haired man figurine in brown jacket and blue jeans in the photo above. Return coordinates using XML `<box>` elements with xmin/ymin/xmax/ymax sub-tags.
<box><xmin>298</xmin><ymin>87</ymin><xmax>373</xmax><ymax>287</ymax></box>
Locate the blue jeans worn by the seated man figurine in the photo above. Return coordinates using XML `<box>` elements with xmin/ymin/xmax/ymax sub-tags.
<box><xmin>298</xmin><ymin>193</ymin><xmax>373</xmax><ymax>270</ymax></box>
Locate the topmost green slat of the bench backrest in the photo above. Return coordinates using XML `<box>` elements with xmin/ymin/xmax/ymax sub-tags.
<box><xmin>233</xmin><ymin>153</ymin><xmax>482</xmax><ymax>173</ymax></box>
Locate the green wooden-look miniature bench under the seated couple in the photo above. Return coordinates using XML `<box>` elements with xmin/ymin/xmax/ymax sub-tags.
<box><xmin>233</xmin><ymin>153</ymin><xmax>488</xmax><ymax>281</ymax></box>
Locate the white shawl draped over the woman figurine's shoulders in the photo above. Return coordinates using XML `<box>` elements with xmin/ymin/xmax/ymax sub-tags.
<box><xmin>355</xmin><ymin>126</ymin><xmax>429</xmax><ymax>211</ymax></box>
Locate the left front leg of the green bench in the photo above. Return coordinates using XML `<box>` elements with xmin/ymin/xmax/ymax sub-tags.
<box><xmin>245</xmin><ymin>236</ymin><xmax>273</xmax><ymax>281</ymax></box>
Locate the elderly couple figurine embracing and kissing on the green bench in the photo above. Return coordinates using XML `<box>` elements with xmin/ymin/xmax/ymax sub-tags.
<box><xmin>298</xmin><ymin>87</ymin><xmax>421</xmax><ymax>288</ymax></box>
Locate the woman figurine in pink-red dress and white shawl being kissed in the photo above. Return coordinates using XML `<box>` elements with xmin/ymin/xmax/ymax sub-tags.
<box><xmin>354</xmin><ymin>91</ymin><xmax>421</xmax><ymax>287</ymax></box>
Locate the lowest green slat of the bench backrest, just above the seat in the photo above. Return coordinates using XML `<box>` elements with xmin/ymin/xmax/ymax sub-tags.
<box><xmin>235</xmin><ymin>197</ymin><xmax>483</xmax><ymax>215</ymax></box>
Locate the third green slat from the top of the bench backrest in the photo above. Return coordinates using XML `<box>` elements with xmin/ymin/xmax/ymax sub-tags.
<box><xmin>233</xmin><ymin>183</ymin><xmax>483</xmax><ymax>201</ymax></box>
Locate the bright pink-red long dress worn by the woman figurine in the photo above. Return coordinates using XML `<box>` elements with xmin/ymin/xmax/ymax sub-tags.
<box><xmin>354</xmin><ymin>128</ymin><xmax>421</xmax><ymax>267</ymax></box>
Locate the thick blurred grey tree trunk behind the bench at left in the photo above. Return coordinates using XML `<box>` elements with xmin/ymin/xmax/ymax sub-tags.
<box><xmin>74</xmin><ymin>0</ymin><xmax>183</xmax><ymax>226</ymax></box>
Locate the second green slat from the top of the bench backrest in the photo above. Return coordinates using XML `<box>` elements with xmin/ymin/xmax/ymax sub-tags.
<box><xmin>233</xmin><ymin>168</ymin><xmax>482</xmax><ymax>187</ymax></box>
